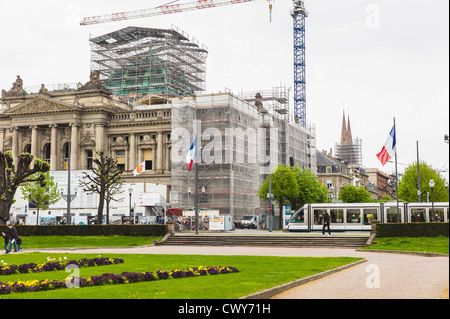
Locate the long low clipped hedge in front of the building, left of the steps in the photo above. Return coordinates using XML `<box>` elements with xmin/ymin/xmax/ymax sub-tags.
<box><xmin>0</xmin><ymin>225</ymin><xmax>167</xmax><ymax>236</ymax></box>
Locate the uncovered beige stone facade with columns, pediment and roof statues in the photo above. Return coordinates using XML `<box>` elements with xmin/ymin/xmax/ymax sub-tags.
<box><xmin>0</xmin><ymin>71</ymin><xmax>171</xmax><ymax>185</ymax></box>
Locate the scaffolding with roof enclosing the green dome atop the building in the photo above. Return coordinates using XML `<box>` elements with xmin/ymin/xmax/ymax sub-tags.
<box><xmin>89</xmin><ymin>25</ymin><xmax>208</xmax><ymax>104</ymax></box>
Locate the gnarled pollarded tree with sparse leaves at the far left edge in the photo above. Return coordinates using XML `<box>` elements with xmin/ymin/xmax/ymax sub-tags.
<box><xmin>0</xmin><ymin>151</ymin><xmax>50</xmax><ymax>225</ymax></box>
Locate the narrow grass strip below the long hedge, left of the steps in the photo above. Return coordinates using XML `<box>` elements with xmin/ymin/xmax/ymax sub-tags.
<box><xmin>14</xmin><ymin>236</ymin><xmax>162</xmax><ymax>249</ymax></box>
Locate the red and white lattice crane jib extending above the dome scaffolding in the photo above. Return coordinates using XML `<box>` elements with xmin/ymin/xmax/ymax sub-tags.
<box><xmin>80</xmin><ymin>0</ymin><xmax>257</xmax><ymax>26</ymax></box>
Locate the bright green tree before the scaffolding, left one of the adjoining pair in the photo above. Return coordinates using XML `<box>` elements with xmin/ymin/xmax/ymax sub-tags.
<box><xmin>257</xmin><ymin>166</ymin><xmax>299</xmax><ymax>228</ymax></box>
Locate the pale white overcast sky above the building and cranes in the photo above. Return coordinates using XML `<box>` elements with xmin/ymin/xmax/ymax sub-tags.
<box><xmin>0</xmin><ymin>0</ymin><xmax>449</xmax><ymax>179</ymax></box>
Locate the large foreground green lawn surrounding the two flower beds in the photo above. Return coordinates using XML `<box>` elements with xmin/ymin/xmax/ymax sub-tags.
<box><xmin>0</xmin><ymin>253</ymin><xmax>360</xmax><ymax>299</ymax></box>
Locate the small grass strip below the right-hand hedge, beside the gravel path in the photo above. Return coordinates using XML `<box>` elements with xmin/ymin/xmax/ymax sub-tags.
<box><xmin>361</xmin><ymin>236</ymin><xmax>449</xmax><ymax>254</ymax></box>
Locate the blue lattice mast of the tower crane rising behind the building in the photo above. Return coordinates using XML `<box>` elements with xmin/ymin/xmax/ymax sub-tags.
<box><xmin>291</xmin><ymin>0</ymin><xmax>308</xmax><ymax>127</ymax></box>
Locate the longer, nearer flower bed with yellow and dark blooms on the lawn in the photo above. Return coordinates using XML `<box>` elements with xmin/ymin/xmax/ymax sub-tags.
<box><xmin>0</xmin><ymin>266</ymin><xmax>239</xmax><ymax>295</ymax></box>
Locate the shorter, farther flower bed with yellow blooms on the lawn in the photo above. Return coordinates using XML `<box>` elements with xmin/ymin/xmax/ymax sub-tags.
<box><xmin>0</xmin><ymin>257</ymin><xmax>124</xmax><ymax>275</ymax></box>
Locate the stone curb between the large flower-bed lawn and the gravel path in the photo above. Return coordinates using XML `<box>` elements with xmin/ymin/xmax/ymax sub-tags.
<box><xmin>238</xmin><ymin>259</ymin><xmax>367</xmax><ymax>299</ymax></box>
